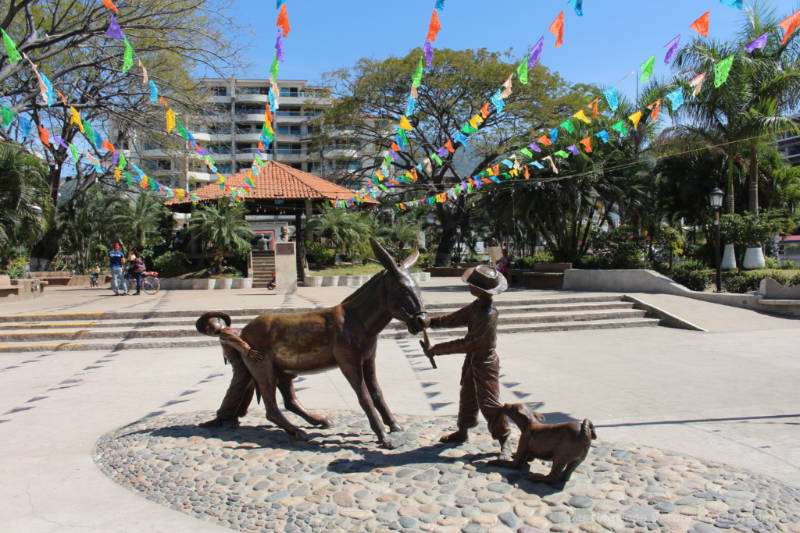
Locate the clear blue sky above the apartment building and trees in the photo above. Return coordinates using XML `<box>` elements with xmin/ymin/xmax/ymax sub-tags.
<box><xmin>211</xmin><ymin>0</ymin><xmax>800</xmax><ymax>95</ymax></box>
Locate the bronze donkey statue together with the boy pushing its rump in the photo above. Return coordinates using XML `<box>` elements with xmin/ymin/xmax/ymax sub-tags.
<box><xmin>197</xmin><ymin>239</ymin><xmax>426</xmax><ymax>448</ymax></box>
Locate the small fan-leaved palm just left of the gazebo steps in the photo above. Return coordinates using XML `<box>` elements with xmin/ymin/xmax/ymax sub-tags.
<box><xmin>189</xmin><ymin>199</ymin><xmax>255</xmax><ymax>272</ymax></box>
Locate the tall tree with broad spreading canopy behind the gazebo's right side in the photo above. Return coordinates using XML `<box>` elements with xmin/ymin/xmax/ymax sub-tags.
<box><xmin>324</xmin><ymin>49</ymin><xmax>587</xmax><ymax>265</ymax></box>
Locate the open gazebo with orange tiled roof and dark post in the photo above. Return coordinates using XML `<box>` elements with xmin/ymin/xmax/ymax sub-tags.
<box><xmin>164</xmin><ymin>161</ymin><xmax>378</xmax><ymax>282</ymax></box>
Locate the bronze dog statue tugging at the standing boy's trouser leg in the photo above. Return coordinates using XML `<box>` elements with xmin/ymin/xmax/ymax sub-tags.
<box><xmin>490</xmin><ymin>403</ymin><xmax>597</xmax><ymax>484</ymax></box>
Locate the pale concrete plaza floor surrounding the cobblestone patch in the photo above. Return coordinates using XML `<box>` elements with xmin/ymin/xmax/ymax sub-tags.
<box><xmin>0</xmin><ymin>279</ymin><xmax>800</xmax><ymax>532</ymax></box>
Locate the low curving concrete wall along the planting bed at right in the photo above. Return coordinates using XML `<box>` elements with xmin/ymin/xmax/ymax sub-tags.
<box><xmin>562</xmin><ymin>268</ymin><xmax>800</xmax><ymax>316</ymax></box>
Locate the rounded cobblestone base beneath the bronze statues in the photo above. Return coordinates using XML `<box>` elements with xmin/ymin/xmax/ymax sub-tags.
<box><xmin>95</xmin><ymin>411</ymin><xmax>800</xmax><ymax>533</ymax></box>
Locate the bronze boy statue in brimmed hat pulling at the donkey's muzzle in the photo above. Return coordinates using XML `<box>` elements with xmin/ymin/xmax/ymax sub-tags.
<box><xmin>420</xmin><ymin>265</ymin><xmax>511</xmax><ymax>459</ymax></box>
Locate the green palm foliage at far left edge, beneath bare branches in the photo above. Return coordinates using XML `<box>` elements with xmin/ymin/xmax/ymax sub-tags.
<box><xmin>0</xmin><ymin>143</ymin><xmax>53</xmax><ymax>260</ymax></box>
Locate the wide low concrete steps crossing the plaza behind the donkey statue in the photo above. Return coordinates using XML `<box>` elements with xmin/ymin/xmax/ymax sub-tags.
<box><xmin>0</xmin><ymin>295</ymin><xmax>659</xmax><ymax>354</ymax></box>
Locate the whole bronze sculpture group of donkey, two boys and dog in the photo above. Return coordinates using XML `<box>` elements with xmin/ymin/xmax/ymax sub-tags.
<box><xmin>197</xmin><ymin>239</ymin><xmax>596</xmax><ymax>483</ymax></box>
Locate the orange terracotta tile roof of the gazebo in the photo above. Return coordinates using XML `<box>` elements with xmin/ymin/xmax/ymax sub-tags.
<box><xmin>165</xmin><ymin>161</ymin><xmax>378</xmax><ymax>205</ymax></box>
